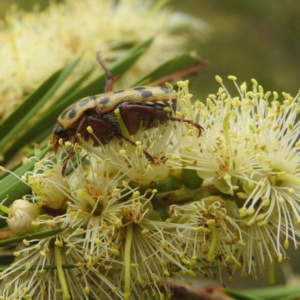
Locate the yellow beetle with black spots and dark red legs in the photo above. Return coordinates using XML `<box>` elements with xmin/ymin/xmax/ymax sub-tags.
<box><xmin>52</xmin><ymin>53</ymin><xmax>203</xmax><ymax>176</ymax></box>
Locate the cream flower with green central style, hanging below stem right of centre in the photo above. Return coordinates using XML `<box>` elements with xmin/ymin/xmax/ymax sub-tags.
<box><xmin>168</xmin><ymin>196</ymin><xmax>244</xmax><ymax>274</ymax></box>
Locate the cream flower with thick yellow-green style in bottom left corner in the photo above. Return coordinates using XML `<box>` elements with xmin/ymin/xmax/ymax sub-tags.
<box><xmin>0</xmin><ymin>227</ymin><xmax>122</xmax><ymax>300</ymax></box>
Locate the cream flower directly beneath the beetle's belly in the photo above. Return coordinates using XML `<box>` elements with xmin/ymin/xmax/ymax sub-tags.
<box><xmin>83</xmin><ymin>122</ymin><xmax>179</xmax><ymax>186</ymax></box>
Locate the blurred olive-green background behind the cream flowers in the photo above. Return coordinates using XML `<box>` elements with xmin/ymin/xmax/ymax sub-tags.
<box><xmin>0</xmin><ymin>0</ymin><xmax>300</xmax><ymax>288</ymax></box>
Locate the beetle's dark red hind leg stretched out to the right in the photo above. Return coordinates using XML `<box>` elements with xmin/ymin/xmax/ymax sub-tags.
<box><xmin>121</xmin><ymin>104</ymin><xmax>204</xmax><ymax>137</ymax></box>
